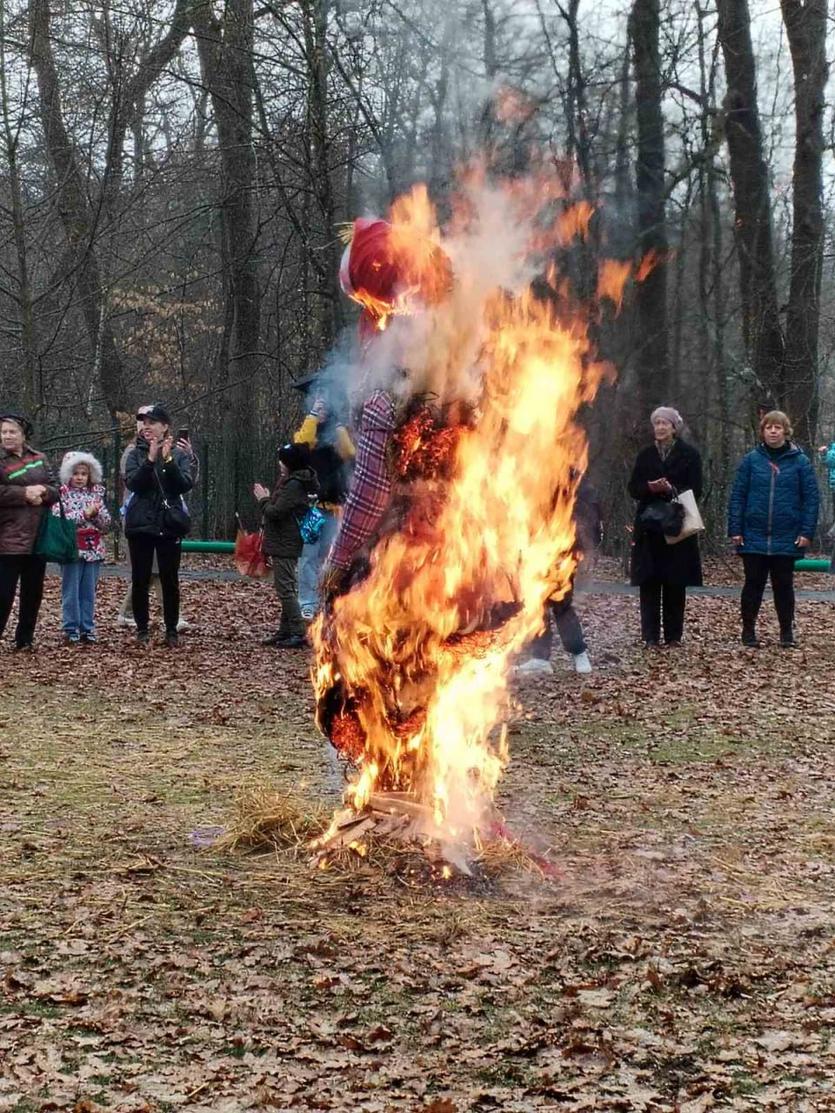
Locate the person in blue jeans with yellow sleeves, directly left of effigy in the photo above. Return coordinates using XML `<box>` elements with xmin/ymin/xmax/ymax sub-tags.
<box><xmin>293</xmin><ymin>380</ymin><xmax>356</xmax><ymax>621</ymax></box>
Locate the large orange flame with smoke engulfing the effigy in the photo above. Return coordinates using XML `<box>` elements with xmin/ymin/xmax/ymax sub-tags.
<box><xmin>314</xmin><ymin>171</ymin><xmax>628</xmax><ymax>859</ymax></box>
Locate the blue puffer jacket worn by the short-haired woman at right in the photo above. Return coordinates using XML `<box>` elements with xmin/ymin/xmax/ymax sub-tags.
<box><xmin>728</xmin><ymin>444</ymin><xmax>821</xmax><ymax>557</ymax></box>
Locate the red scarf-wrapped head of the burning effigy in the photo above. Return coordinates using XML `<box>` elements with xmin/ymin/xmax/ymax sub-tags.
<box><xmin>340</xmin><ymin>217</ymin><xmax>452</xmax><ymax>339</ymax></box>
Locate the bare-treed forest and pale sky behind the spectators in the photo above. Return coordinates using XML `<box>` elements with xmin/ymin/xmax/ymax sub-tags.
<box><xmin>0</xmin><ymin>0</ymin><xmax>835</xmax><ymax>549</ymax></box>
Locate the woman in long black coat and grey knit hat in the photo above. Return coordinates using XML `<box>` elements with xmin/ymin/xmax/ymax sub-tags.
<box><xmin>629</xmin><ymin>406</ymin><xmax>701</xmax><ymax>649</ymax></box>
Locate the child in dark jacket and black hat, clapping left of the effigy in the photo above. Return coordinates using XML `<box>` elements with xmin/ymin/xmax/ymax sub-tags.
<box><xmin>253</xmin><ymin>444</ymin><xmax>318</xmax><ymax>649</ymax></box>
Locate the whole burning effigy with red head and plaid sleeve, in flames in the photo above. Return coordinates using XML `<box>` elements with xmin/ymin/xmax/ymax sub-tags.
<box><xmin>313</xmin><ymin>175</ymin><xmax>626</xmax><ymax>871</ymax></box>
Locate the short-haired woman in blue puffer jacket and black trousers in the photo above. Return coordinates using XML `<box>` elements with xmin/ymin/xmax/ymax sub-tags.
<box><xmin>728</xmin><ymin>410</ymin><xmax>819</xmax><ymax>649</ymax></box>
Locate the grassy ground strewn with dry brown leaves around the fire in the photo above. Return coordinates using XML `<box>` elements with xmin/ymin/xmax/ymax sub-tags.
<box><xmin>0</xmin><ymin>580</ymin><xmax>835</xmax><ymax>1113</ymax></box>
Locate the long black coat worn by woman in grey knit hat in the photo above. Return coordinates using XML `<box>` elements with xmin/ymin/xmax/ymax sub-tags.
<box><xmin>629</xmin><ymin>440</ymin><xmax>701</xmax><ymax>588</ymax></box>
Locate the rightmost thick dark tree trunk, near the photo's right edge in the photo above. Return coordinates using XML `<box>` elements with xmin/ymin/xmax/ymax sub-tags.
<box><xmin>780</xmin><ymin>0</ymin><xmax>828</xmax><ymax>447</ymax></box>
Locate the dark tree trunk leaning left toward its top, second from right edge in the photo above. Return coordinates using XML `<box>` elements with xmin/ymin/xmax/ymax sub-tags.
<box><xmin>716</xmin><ymin>0</ymin><xmax>785</xmax><ymax>404</ymax></box>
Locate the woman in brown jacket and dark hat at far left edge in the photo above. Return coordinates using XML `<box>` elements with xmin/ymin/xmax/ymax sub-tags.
<box><xmin>0</xmin><ymin>413</ymin><xmax>58</xmax><ymax>649</ymax></box>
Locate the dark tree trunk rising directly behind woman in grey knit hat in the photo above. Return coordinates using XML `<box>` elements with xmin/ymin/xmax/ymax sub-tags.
<box><xmin>629</xmin><ymin>0</ymin><xmax>669</xmax><ymax>412</ymax></box>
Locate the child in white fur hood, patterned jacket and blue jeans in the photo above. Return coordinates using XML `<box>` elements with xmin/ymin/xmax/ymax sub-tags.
<box><xmin>52</xmin><ymin>452</ymin><xmax>110</xmax><ymax>644</ymax></box>
